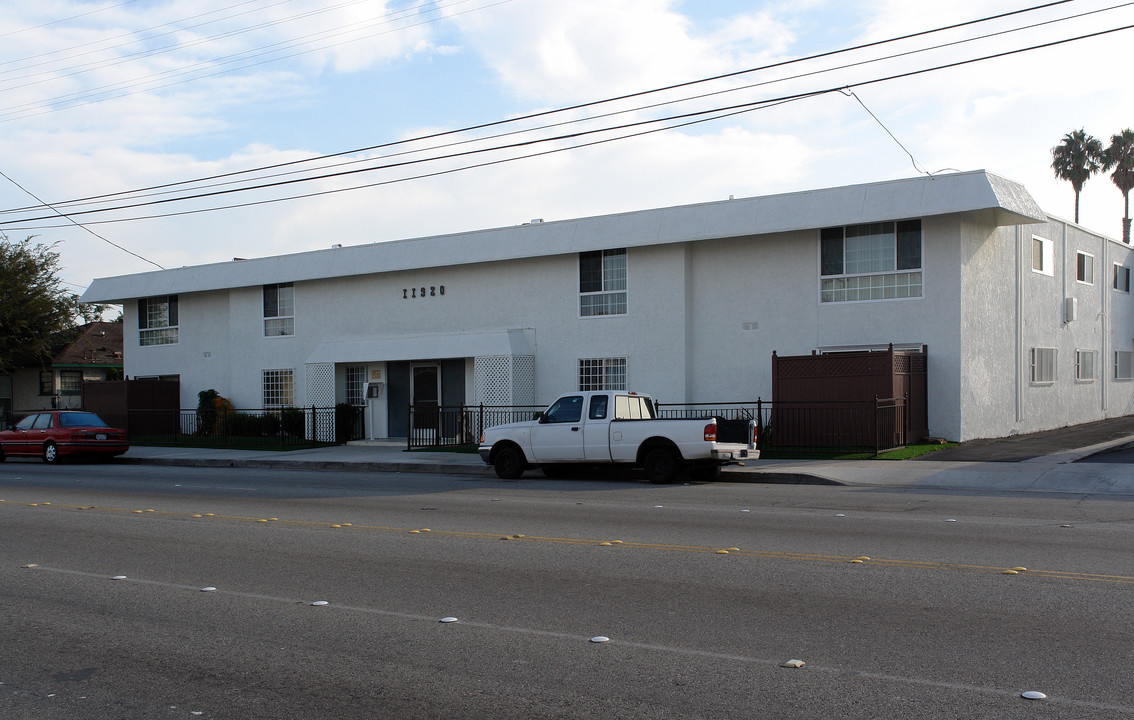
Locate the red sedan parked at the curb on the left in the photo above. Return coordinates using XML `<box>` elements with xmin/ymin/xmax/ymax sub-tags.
<box><xmin>0</xmin><ymin>410</ymin><xmax>130</xmax><ymax>463</ymax></box>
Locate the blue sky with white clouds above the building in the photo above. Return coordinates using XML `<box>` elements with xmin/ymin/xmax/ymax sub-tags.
<box><xmin>0</xmin><ymin>0</ymin><xmax>1134</xmax><ymax>303</ymax></box>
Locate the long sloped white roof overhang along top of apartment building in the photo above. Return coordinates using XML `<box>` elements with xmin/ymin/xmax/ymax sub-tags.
<box><xmin>81</xmin><ymin>170</ymin><xmax>1047</xmax><ymax>303</ymax></box>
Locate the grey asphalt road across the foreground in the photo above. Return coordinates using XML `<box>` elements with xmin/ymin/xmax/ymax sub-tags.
<box><xmin>0</xmin><ymin>460</ymin><xmax>1134</xmax><ymax>720</ymax></box>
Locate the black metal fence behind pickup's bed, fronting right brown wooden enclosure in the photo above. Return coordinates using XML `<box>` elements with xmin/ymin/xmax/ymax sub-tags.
<box><xmin>655</xmin><ymin>398</ymin><xmax>909</xmax><ymax>455</ymax></box>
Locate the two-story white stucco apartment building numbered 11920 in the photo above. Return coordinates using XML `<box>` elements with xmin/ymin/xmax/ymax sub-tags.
<box><xmin>82</xmin><ymin>171</ymin><xmax>1134</xmax><ymax>440</ymax></box>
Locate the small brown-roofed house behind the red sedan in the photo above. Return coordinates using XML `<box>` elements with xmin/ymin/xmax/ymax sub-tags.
<box><xmin>0</xmin><ymin>322</ymin><xmax>122</xmax><ymax>422</ymax></box>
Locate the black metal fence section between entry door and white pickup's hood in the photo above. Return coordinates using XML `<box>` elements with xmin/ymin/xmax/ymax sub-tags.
<box><xmin>406</xmin><ymin>404</ymin><xmax>544</xmax><ymax>450</ymax></box>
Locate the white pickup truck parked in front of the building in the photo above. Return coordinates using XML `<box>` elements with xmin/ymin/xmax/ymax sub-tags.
<box><xmin>477</xmin><ymin>391</ymin><xmax>760</xmax><ymax>483</ymax></box>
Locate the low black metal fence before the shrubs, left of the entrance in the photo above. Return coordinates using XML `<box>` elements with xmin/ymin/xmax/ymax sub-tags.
<box><xmin>92</xmin><ymin>405</ymin><xmax>363</xmax><ymax>450</ymax></box>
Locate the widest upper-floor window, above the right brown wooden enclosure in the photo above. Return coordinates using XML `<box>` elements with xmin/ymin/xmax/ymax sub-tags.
<box><xmin>819</xmin><ymin>220</ymin><xmax>922</xmax><ymax>303</ymax></box>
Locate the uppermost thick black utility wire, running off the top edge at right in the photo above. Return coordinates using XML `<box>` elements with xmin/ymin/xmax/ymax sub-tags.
<box><xmin>2</xmin><ymin>0</ymin><xmax>1088</xmax><ymax>212</ymax></box>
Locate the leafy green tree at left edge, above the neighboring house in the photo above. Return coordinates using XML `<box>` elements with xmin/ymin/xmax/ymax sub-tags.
<box><xmin>0</xmin><ymin>235</ymin><xmax>84</xmax><ymax>371</ymax></box>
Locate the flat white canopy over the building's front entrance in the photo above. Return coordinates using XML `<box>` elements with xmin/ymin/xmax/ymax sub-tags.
<box><xmin>306</xmin><ymin>329</ymin><xmax>535</xmax><ymax>365</ymax></box>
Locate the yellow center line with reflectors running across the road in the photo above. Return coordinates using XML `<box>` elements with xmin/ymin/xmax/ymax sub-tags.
<box><xmin>8</xmin><ymin>500</ymin><xmax>1134</xmax><ymax>584</ymax></box>
